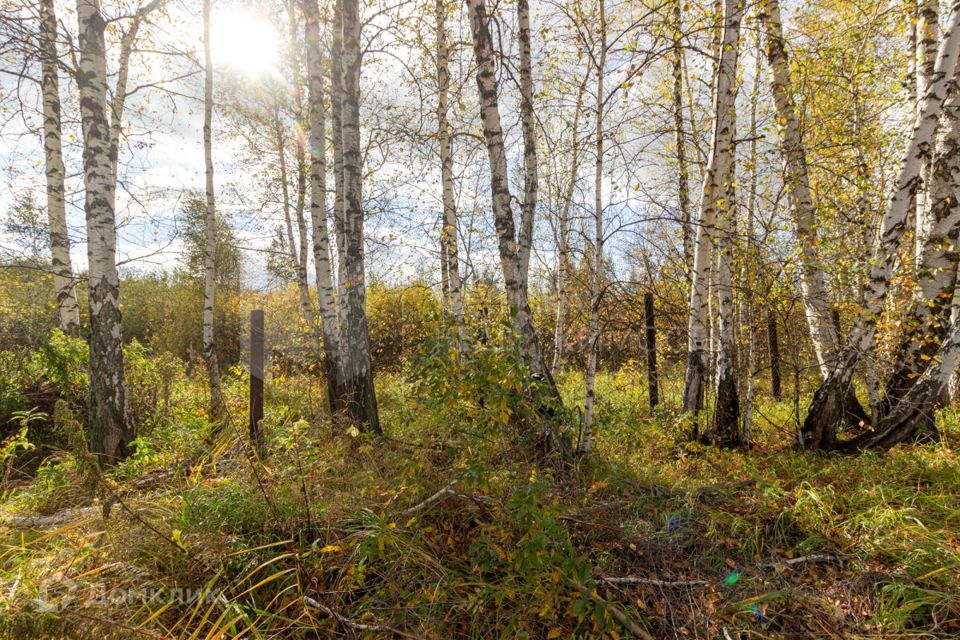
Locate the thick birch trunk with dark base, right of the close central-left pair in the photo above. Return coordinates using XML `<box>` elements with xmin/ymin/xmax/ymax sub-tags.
<box><xmin>340</xmin><ymin>0</ymin><xmax>381</xmax><ymax>434</ymax></box>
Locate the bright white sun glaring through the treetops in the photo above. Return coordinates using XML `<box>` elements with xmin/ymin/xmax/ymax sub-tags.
<box><xmin>211</xmin><ymin>5</ymin><xmax>279</xmax><ymax>78</ymax></box>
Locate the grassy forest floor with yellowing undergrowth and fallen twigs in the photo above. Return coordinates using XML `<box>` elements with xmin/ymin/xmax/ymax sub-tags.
<box><xmin>0</xmin><ymin>370</ymin><xmax>960</xmax><ymax>640</ymax></box>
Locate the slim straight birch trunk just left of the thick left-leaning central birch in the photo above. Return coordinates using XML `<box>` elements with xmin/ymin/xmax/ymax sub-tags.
<box><xmin>436</xmin><ymin>0</ymin><xmax>466</xmax><ymax>348</ymax></box>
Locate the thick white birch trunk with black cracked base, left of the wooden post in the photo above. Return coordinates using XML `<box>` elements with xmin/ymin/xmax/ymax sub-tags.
<box><xmin>77</xmin><ymin>0</ymin><xmax>136</xmax><ymax>464</ymax></box>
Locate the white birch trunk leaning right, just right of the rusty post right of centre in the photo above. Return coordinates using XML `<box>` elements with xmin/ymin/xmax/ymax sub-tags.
<box><xmin>682</xmin><ymin>0</ymin><xmax>743</xmax><ymax>424</ymax></box>
